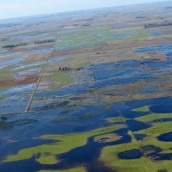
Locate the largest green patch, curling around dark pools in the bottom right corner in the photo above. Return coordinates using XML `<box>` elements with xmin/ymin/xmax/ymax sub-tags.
<box><xmin>100</xmin><ymin>122</ymin><xmax>172</xmax><ymax>172</ymax></box>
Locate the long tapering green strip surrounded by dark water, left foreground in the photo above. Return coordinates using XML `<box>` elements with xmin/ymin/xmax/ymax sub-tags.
<box><xmin>3</xmin><ymin>125</ymin><xmax>124</xmax><ymax>163</ymax></box>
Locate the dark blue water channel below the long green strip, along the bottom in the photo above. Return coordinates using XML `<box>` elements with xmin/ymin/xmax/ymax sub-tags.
<box><xmin>0</xmin><ymin>129</ymin><xmax>131</xmax><ymax>172</ymax></box>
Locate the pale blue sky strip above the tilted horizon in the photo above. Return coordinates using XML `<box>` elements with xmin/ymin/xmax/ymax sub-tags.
<box><xmin>0</xmin><ymin>0</ymin><xmax>167</xmax><ymax>19</ymax></box>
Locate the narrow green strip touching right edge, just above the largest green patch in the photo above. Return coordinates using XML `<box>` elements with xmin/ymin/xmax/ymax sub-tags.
<box><xmin>136</xmin><ymin>113</ymin><xmax>172</xmax><ymax>122</ymax></box>
